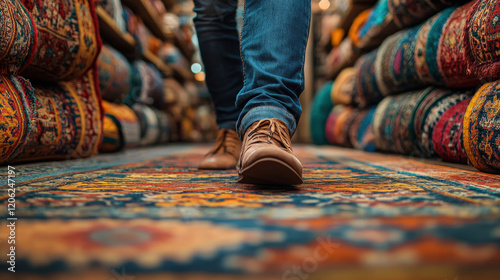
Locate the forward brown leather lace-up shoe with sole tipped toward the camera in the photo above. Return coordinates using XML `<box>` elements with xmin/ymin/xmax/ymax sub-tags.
<box><xmin>238</xmin><ymin>119</ymin><xmax>302</xmax><ymax>185</ymax></box>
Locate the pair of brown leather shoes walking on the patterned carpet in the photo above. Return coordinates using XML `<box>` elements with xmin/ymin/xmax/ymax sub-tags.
<box><xmin>199</xmin><ymin>119</ymin><xmax>302</xmax><ymax>185</ymax></box>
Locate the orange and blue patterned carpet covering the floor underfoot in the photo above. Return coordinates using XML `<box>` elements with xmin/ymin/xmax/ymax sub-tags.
<box><xmin>0</xmin><ymin>145</ymin><xmax>500</xmax><ymax>280</ymax></box>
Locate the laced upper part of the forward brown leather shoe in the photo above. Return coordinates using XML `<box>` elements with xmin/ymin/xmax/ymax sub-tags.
<box><xmin>248</xmin><ymin>119</ymin><xmax>292</xmax><ymax>151</ymax></box>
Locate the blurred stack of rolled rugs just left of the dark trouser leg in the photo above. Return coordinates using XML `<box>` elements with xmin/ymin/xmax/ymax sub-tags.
<box><xmin>96</xmin><ymin>0</ymin><xmax>216</xmax><ymax>152</ymax></box>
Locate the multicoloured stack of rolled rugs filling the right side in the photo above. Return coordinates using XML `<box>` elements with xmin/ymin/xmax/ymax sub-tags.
<box><xmin>313</xmin><ymin>0</ymin><xmax>500</xmax><ymax>173</ymax></box>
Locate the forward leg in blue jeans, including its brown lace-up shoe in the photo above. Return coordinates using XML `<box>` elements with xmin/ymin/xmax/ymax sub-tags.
<box><xmin>236</xmin><ymin>0</ymin><xmax>311</xmax><ymax>185</ymax></box>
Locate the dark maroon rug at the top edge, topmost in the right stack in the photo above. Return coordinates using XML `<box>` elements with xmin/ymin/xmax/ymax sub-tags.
<box><xmin>388</xmin><ymin>0</ymin><xmax>470</xmax><ymax>28</ymax></box>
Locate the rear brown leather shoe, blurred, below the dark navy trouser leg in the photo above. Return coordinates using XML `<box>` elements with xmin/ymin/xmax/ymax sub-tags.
<box><xmin>198</xmin><ymin>129</ymin><xmax>241</xmax><ymax>170</ymax></box>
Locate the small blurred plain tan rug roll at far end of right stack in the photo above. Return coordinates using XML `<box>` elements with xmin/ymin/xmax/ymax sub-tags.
<box><xmin>331</xmin><ymin>67</ymin><xmax>359</xmax><ymax>105</ymax></box>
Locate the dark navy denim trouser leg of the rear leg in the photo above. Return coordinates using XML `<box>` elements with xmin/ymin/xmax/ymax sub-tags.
<box><xmin>194</xmin><ymin>0</ymin><xmax>243</xmax><ymax>130</ymax></box>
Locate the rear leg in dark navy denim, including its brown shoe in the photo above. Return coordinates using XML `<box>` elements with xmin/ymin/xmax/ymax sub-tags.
<box><xmin>194</xmin><ymin>0</ymin><xmax>243</xmax><ymax>170</ymax></box>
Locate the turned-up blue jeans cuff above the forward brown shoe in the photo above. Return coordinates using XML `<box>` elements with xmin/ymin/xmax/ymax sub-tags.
<box><xmin>238</xmin><ymin>106</ymin><xmax>297</xmax><ymax>140</ymax></box>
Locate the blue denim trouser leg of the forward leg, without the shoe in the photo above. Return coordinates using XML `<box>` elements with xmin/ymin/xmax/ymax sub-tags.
<box><xmin>236</xmin><ymin>0</ymin><xmax>311</xmax><ymax>136</ymax></box>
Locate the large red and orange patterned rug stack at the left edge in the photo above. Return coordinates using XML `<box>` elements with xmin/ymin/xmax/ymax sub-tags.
<box><xmin>0</xmin><ymin>0</ymin><xmax>103</xmax><ymax>164</ymax></box>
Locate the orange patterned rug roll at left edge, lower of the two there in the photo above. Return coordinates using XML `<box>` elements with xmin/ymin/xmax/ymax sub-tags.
<box><xmin>0</xmin><ymin>75</ymin><xmax>36</xmax><ymax>165</ymax></box>
